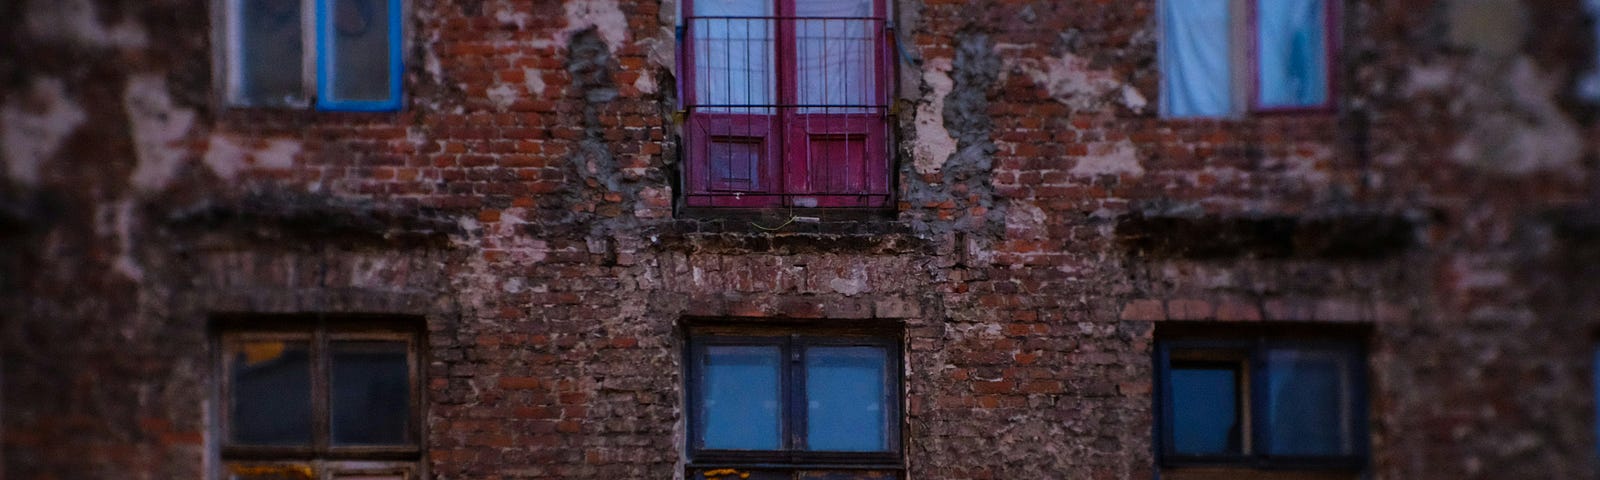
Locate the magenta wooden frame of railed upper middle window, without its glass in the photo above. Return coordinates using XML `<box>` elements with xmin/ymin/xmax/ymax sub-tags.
<box><xmin>677</xmin><ymin>0</ymin><xmax>898</xmax><ymax>211</ymax></box>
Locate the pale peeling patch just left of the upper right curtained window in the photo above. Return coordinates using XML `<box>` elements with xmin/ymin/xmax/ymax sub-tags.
<box><xmin>1014</xmin><ymin>53</ymin><xmax>1146</xmax><ymax>110</ymax></box>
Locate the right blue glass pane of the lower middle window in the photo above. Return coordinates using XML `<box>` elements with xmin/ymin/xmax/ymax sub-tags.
<box><xmin>805</xmin><ymin>347</ymin><xmax>890</xmax><ymax>451</ymax></box>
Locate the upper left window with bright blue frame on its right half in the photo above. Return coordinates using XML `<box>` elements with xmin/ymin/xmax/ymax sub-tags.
<box><xmin>221</xmin><ymin>0</ymin><xmax>402</xmax><ymax>112</ymax></box>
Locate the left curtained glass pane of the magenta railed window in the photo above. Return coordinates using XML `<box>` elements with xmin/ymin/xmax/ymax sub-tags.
<box><xmin>688</xmin><ymin>0</ymin><xmax>778</xmax><ymax>114</ymax></box>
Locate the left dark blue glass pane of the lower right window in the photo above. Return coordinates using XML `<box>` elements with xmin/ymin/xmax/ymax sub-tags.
<box><xmin>1170</xmin><ymin>366</ymin><xmax>1240</xmax><ymax>454</ymax></box>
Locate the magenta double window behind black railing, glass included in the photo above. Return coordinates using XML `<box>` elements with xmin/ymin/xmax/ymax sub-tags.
<box><xmin>680</xmin><ymin>0</ymin><xmax>891</xmax><ymax>208</ymax></box>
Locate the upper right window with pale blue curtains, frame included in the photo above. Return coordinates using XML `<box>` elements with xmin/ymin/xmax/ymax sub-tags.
<box><xmin>1160</xmin><ymin>0</ymin><xmax>1338</xmax><ymax>117</ymax></box>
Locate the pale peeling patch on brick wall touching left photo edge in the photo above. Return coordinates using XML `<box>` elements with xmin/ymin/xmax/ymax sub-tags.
<box><xmin>0</xmin><ymin>77</ymin><xmax>86</xmax><ymax>184</ymax></box>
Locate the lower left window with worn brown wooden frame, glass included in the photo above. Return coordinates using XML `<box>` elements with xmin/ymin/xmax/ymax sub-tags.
<box><xmin>218</xmin><ymin>318</ymin><xmax>422</xmax><ymax>480</ymax></box>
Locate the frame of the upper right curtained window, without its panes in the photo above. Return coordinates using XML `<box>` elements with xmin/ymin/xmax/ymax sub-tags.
<box><xmin>1155</xmin><ymin>0</ymin><xmax>1344</xmax><ymax>120</ymax></box>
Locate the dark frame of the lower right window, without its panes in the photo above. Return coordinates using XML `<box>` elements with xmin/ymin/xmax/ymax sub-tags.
<box><xmin>1154</xmin><ymin>336</ymin><xmax>1371</xmax><ymax>470</ymax></box>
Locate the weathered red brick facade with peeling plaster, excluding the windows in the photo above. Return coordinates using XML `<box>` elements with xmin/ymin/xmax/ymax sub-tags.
<box><xmin>0</xmin><ymin>0</ymin><xmax>1600</xmax><ymax>478</ymax></box>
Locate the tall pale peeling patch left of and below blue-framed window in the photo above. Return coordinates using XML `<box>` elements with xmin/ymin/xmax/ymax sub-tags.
<box><xmin>123</xmin><ymin>74</ymin><xmax>195</xmax><ymax>190</ymax></box>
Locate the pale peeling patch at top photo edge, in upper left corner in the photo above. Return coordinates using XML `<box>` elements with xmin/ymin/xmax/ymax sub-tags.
<box><xmin>24</xmin><ymin>0</ymin><xmax>150</xmax><ymax>48</ymax></box>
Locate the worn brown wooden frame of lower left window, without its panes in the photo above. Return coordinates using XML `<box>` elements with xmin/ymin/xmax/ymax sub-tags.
<box><xmin>211</xmin><ymin>315</ymin><xmax>427</xmax><ymax>478</ymax></box>
